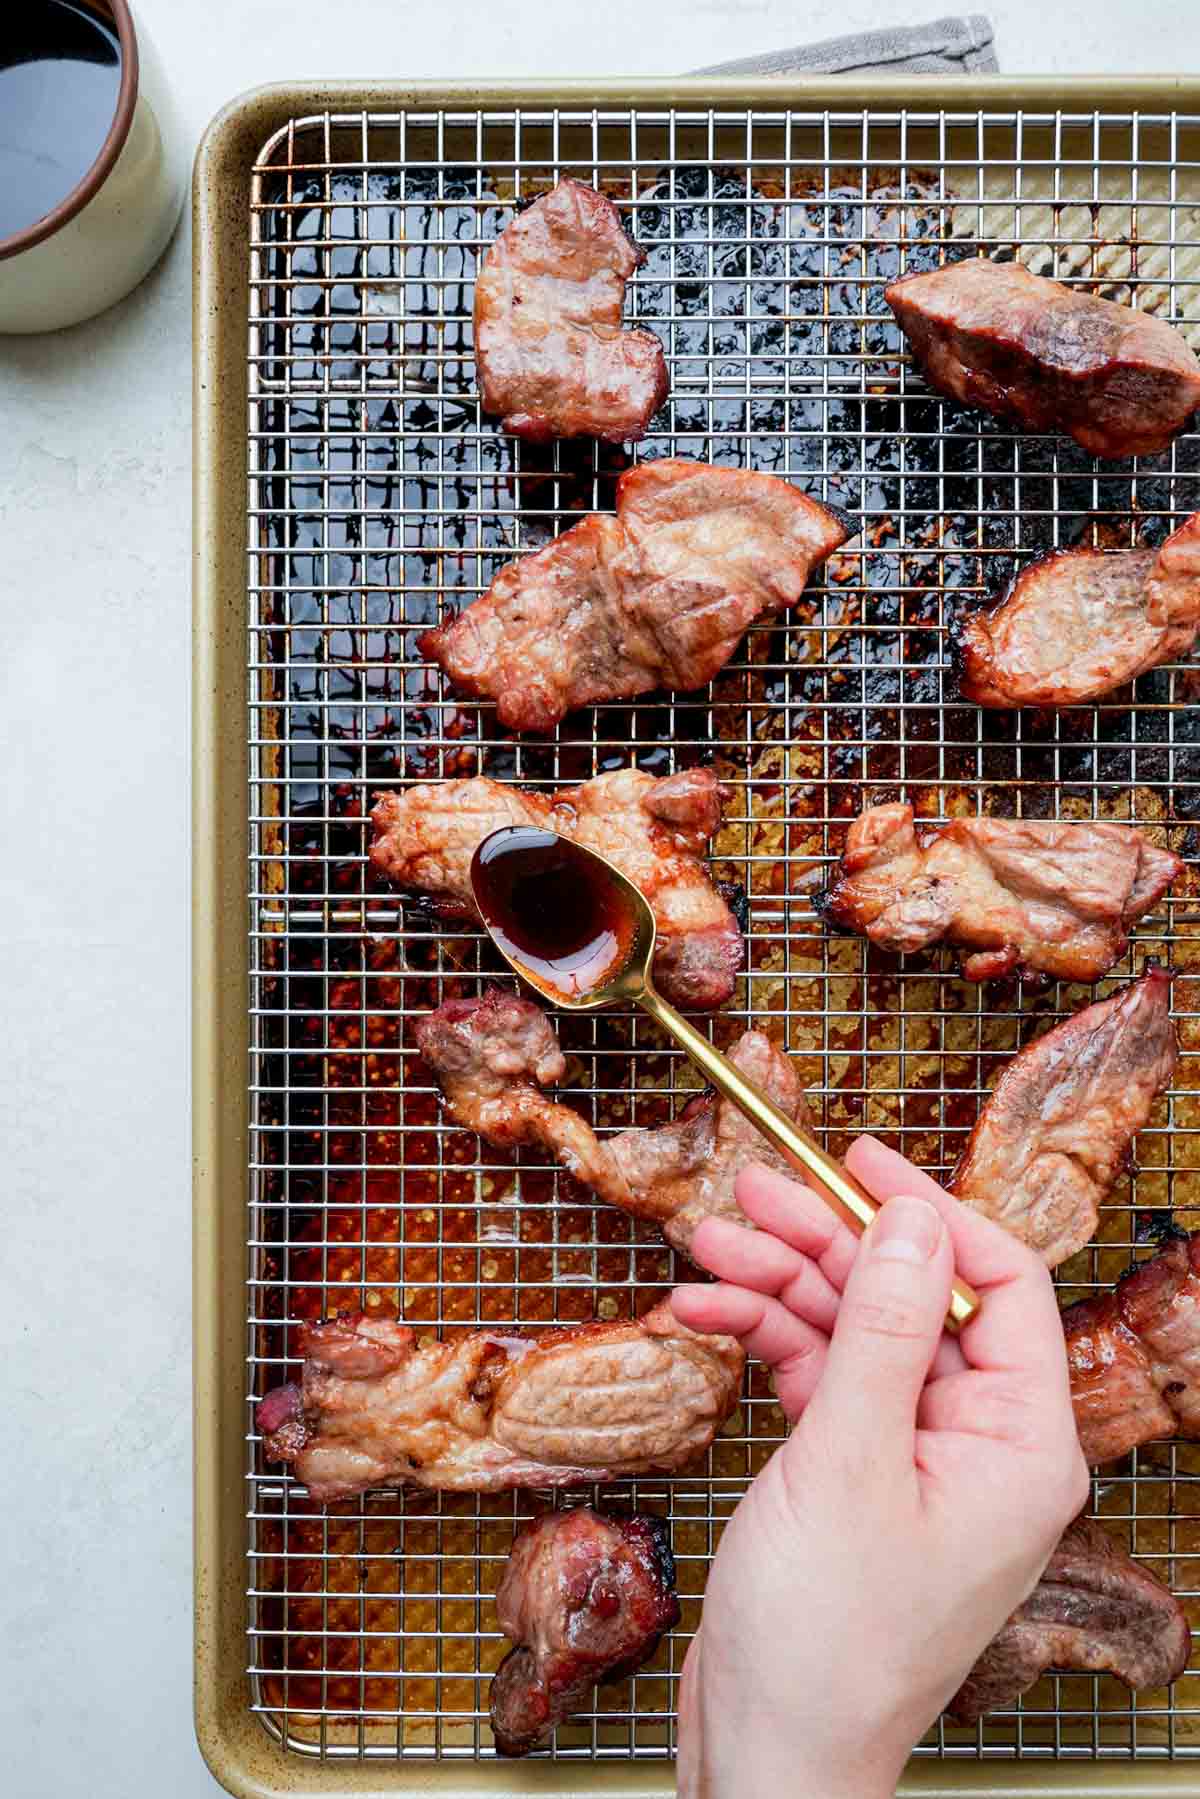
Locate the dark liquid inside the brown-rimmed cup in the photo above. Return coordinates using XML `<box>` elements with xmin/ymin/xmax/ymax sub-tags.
<box><xmin>0</xmin><ymin>0</ymin><xmax>121</xmax><ymax>239</ymax></box>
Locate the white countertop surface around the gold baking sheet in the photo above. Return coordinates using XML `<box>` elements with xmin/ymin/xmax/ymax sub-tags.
<box><xmin>0</xmin><ymin>0</ymin><xmax>1180</xmax><ymax>1799</ymax></box>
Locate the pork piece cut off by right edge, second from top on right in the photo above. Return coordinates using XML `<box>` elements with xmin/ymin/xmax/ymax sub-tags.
<box><xmin>955</xmin><ymin>513</ymin><xmax>1200</xmax><ymax>707</ymax></box>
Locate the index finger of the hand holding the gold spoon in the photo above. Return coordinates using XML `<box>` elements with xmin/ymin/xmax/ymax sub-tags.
<box><xmin>846</xmin><ymin>1137</ymin><xmax>1067</xmax><ymax>1389</ymax></box>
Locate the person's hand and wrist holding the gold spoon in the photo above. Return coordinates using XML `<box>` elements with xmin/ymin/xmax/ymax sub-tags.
<box><xmin>671</xmin><ymin>1137</ymin><xmax>1088</xmax><ymax>1799</ymax></box>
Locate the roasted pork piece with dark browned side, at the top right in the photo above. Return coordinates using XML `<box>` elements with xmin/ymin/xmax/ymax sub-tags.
<box><xmin>883</xmin><ymin>261</ymin><xmax>1200</xmax><ymax>457</ymax></box>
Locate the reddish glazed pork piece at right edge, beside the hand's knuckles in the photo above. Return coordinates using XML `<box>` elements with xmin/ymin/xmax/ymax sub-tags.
<box><xmin>1063</xmin><ymin>1232</ymin><xmax>1200</xmax><ymax>1463</ymax></box>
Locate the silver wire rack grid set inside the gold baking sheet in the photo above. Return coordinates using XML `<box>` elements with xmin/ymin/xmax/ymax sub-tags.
<box><xmin>244</xmin><ymin>108</ymin><xmax>1200</xmax><ymax>1758</ymax></box>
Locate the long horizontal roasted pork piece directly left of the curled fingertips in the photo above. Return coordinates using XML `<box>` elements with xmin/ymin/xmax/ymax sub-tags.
<box><xmin>257</xmin><ymin>1299</ymin><xmax>745</xmax><ymax>1502</ymax></box>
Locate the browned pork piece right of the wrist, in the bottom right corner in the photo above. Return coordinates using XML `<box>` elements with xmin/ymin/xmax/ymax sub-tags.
<box><xmin>946</xmin><ymin>1518</ymin><xmax>1191</xmax><ymax>1723</ymax></box>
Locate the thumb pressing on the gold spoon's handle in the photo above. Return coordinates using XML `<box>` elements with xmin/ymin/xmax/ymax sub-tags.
<box><xmin>810</xmin><ymin>1195</ymin><xmax>954</xmax><ymax>1463</ymax></box>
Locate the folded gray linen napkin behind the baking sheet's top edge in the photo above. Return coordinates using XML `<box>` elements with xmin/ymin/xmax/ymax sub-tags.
<box><xmin>691</xmin><ymin>13</ymin><xmax>1000</xmax><ymax>76</ymax></box>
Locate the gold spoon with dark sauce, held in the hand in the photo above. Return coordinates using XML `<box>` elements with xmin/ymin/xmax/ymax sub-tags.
<box><xmin>471</xmin><ymin>824</ymin><xmax>979</xmax><ymax>1331</ymax></box>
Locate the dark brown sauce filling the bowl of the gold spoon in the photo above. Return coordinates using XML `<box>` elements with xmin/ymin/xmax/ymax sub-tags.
<box><xmin>471</xmin><ymin>824</ymin><xmax>633</xmax><ymax>998</ymax></box>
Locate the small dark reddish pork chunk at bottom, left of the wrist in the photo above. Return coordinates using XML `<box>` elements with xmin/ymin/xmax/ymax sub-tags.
<box><xmin>491</xmin><ymin>1508</ymin><xmax>680</xmax><ymax>1756</ymax></box>
